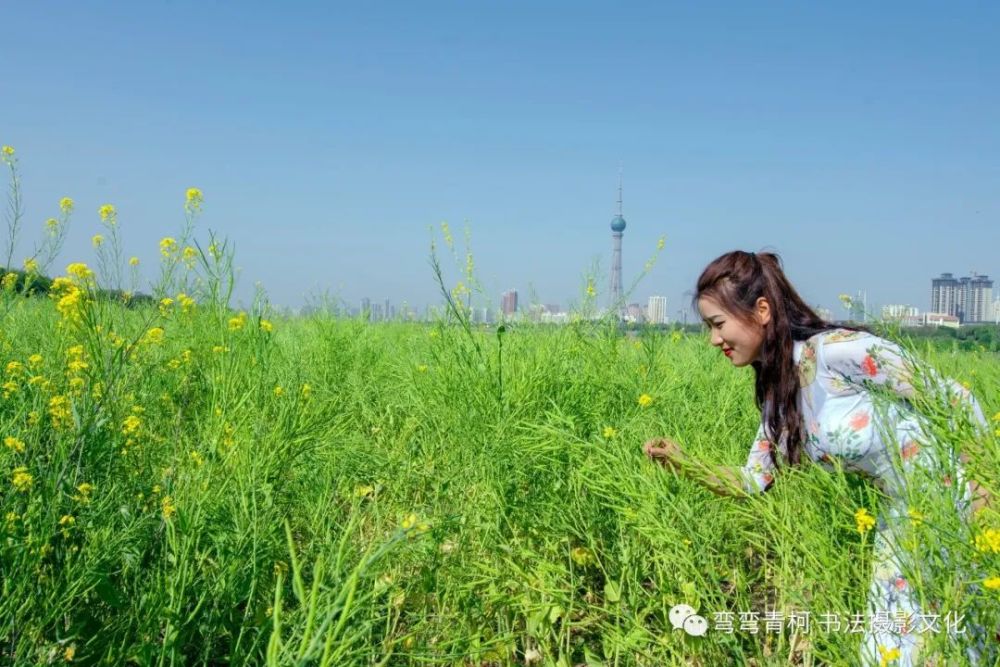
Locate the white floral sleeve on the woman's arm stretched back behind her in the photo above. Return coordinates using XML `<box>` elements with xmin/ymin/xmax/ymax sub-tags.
<box><xmin>820</xmin><ymin>333</ymin><xmax>987</xmax><ymax>424</ymax></box>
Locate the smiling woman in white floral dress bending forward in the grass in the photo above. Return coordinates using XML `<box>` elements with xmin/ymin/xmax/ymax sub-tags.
<box><xmin>644</xmin><ymin>251</ymin><xmax>986</xmax><ymax>665</ymax></box>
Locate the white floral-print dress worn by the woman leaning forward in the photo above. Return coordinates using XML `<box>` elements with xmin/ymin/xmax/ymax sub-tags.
<box><xmin>742</xmin><ymin>329</ymin><xmax>986</xmax><ymax>665</ymax></box>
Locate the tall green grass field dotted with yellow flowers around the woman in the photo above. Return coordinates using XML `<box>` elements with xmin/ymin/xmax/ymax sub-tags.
<box><xmin>0</xmin><ymin>149</ymin><xmax>1000</xmax><ymax>666</ymax></box>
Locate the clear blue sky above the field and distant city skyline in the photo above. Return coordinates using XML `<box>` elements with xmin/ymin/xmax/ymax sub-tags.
<box><xmin>0</xmin><ymin>1</ymin><xmax>1000</xmax><ymax>317</ymax></box>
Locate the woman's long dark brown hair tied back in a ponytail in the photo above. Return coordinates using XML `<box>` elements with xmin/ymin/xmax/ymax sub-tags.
<box><xmin>694</xmin><ymin>250</ymin><xmax>838</xmax><ymax>466</ymax></box>
